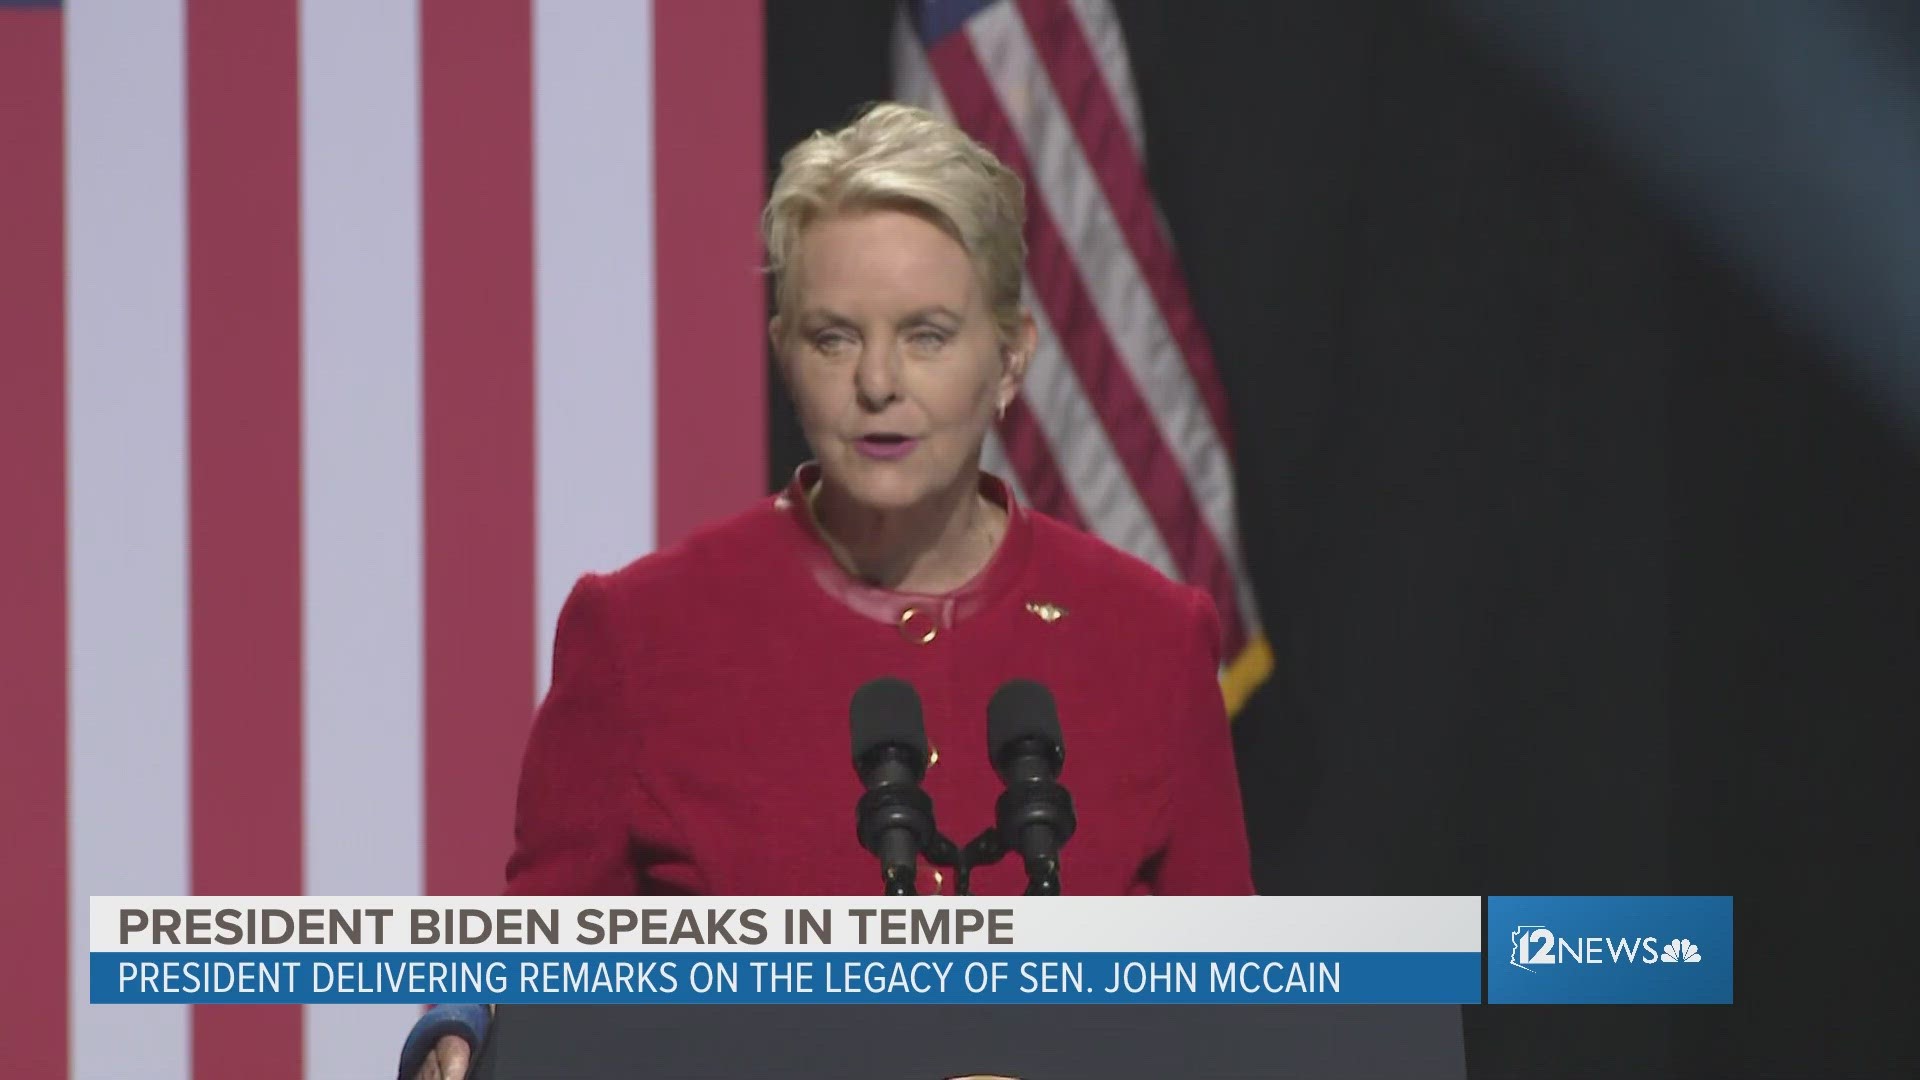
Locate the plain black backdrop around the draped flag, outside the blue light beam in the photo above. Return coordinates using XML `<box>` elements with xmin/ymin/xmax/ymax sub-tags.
<box><xmin>768</xmin><ymin>0</ymin><xmax>1920</xmax><ymax>1078</ymax></box>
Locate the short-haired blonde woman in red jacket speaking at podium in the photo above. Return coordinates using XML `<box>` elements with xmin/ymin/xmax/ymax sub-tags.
<box><xmin>403</xmin><ymin>104</ymin><xmax>1252</xmax><ymax>1080</ymax></box>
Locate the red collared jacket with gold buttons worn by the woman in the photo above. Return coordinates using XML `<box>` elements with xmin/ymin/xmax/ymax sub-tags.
<box><xmin>507</xmin><ymin>469</ymin><xmax>1252</xmax><ymax>896</ymax></box>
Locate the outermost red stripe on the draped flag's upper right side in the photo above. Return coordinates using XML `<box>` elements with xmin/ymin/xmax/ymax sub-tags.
<box><xmin>1018</xmin><ymin>0</ymin><xmax>1233</xmax><ymax>454</ymax></box>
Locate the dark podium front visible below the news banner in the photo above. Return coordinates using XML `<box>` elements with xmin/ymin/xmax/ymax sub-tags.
<box><xmin>474</xmin><ymin>1005</ymin><xmax>1467</xmax><ymax>1080</ymax></box>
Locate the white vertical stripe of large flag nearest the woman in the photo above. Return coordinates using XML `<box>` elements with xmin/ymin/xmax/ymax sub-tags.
<box><xmin>534</xmin><ymin>0</ymin><xmax>655</xmax><ymax>694</ymax></box>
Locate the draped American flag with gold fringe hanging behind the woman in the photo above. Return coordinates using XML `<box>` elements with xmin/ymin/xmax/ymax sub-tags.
<box><xmin>893</xmin><ymin>0</ymin><xmax>1273</xmax><ymax>711</ymax></box>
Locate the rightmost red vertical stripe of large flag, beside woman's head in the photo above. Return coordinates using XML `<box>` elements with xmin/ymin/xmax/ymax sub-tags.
<box><xmin>653</xmin><ymin>0</ymin><xmax>766</xmax><ymax>548</ymax></box>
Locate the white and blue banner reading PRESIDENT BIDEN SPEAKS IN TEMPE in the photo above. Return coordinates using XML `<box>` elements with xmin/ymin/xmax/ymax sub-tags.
<box><xmin>88</xmin><ymin>896</ymin><xmax>1482</xmax><ymax>1005</ymax></box>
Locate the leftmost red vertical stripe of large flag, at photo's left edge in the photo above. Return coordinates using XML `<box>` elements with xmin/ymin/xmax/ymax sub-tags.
<box><xmin>0</xmin><ymin>10</ymin><xmax>67</xmax><ymax>1076</ymax></box>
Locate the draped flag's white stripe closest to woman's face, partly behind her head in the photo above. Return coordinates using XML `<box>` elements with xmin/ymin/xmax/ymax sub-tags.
<box><xmin>893</xmin><ymin>8</ymin><xmax>1179</xmax><ymax>578</ymax></box>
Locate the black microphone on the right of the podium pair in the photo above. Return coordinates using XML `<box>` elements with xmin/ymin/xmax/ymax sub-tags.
<box><xmin>987</xmin><ymin>678</ymin><xmax>1075</xmax><ymax>896</ymax></box>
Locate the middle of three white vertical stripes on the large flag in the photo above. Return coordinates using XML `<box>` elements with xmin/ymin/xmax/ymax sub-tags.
<box><xmin>300</xmin><ymin>0</ymin><xmax>424</xmax><ymax>1076</ymax></box>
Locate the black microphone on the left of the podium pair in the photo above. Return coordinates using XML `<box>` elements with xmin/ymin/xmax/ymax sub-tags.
<box><xmin>847</xmin><ymin>678</ymin><xmax>937</xmax><ymax>896</ymax></box>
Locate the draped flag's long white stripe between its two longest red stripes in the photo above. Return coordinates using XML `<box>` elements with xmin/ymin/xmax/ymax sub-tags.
<box><xmin>966</xmin><ymin>4</ymin><xmax>1254</xmax><ymax>619</ymax></box>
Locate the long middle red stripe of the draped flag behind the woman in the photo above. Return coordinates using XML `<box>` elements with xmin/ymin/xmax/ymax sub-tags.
<box><xmin>927</xmin><ymin>33</ymin><xmax>1246</xmax><ymax>655</ymax></box>
